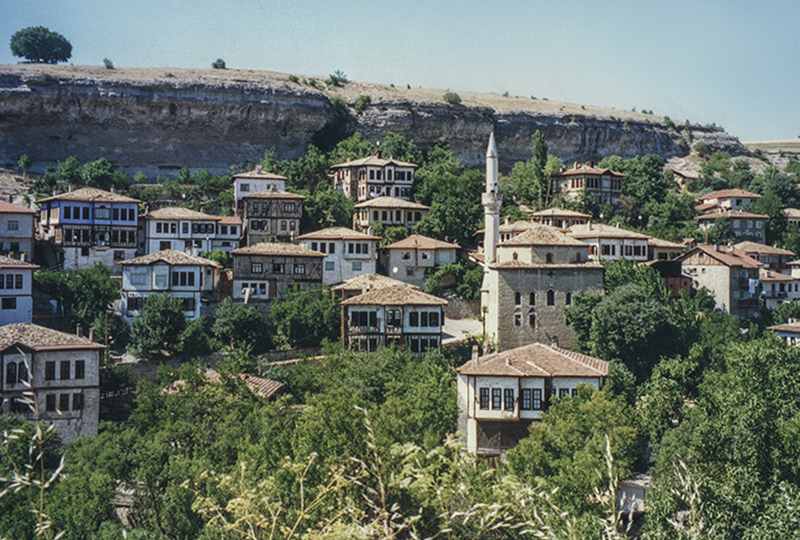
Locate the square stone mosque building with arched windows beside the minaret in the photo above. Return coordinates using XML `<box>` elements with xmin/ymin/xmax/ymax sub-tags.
<box><xmin>481</xmin><ymin>224</ymin><xmax>603</xmax><ymax>351</ymax></box>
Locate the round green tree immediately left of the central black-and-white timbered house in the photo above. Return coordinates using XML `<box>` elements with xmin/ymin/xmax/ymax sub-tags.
<box><xmin>270</xmin><ymin>285</ymin><xmax>341</xmax><ymax>348</ymax></box>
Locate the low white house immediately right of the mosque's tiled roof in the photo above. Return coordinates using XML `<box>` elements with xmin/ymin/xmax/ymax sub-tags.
<box><xmin>569</xmin><ymin>222</ymin><xmax>650</xmax><ymax>262</ymax></box>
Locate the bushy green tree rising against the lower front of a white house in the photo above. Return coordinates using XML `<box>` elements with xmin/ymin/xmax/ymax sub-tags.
<box><xmin>128</xmin><ymin>293</ymin><xmax>186</xmax><ymax>358</ymax></box>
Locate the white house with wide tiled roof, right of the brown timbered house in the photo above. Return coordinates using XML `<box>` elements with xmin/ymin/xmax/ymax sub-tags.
<box><xmin>297</xmin><ymin>227</ymin><xmax>380</xmax><ymax>285</ymax></box>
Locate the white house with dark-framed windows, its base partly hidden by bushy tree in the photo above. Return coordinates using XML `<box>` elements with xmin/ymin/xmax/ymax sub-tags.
<box><xmin>121</xmin><ymin>249</ymin><xmax>222</xmax><ymax>322</ymax></box>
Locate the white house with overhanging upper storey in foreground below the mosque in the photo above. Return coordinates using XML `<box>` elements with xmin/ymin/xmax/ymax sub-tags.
<box><xmin>456</xmin><ymin>343</ymin><xmax>608</xmax><ymax>455</ymax></box>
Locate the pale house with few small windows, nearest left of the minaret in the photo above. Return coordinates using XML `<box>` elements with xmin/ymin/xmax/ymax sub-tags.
<box><xmin>380</xmin><ymin>234</ymin><xmax>460</xmax><ymax>287</ymax></box>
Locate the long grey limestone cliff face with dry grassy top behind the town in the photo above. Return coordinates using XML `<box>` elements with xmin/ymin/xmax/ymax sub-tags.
<box><xmin>0</xmin><ymin>66</ymin><xmax>747</xmax><ymax>176</ymax></box>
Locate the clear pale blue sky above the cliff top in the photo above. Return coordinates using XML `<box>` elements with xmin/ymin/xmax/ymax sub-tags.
<box><xmin>0</xmin><ymin>0</ymin><xmax>800</xmax><ymax>142</ymax></box>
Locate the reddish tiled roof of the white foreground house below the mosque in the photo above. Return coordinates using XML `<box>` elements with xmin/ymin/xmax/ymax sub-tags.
<box><xmin>457</xmin><ymin>343</ymin><xmax>608</xmax><ymax>377</ymax></box>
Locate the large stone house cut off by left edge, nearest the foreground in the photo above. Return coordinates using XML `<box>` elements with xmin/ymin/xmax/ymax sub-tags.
<box><xmin>0</xmin><ymin>323</ymin><xmax>105</xmax><ymax>443</ymax></box>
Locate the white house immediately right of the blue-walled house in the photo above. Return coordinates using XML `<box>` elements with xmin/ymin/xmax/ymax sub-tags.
<box><xmin>143</xmin><ymin>206</ymin><xmax>221</xmax><ymax>255</ymax></box>
